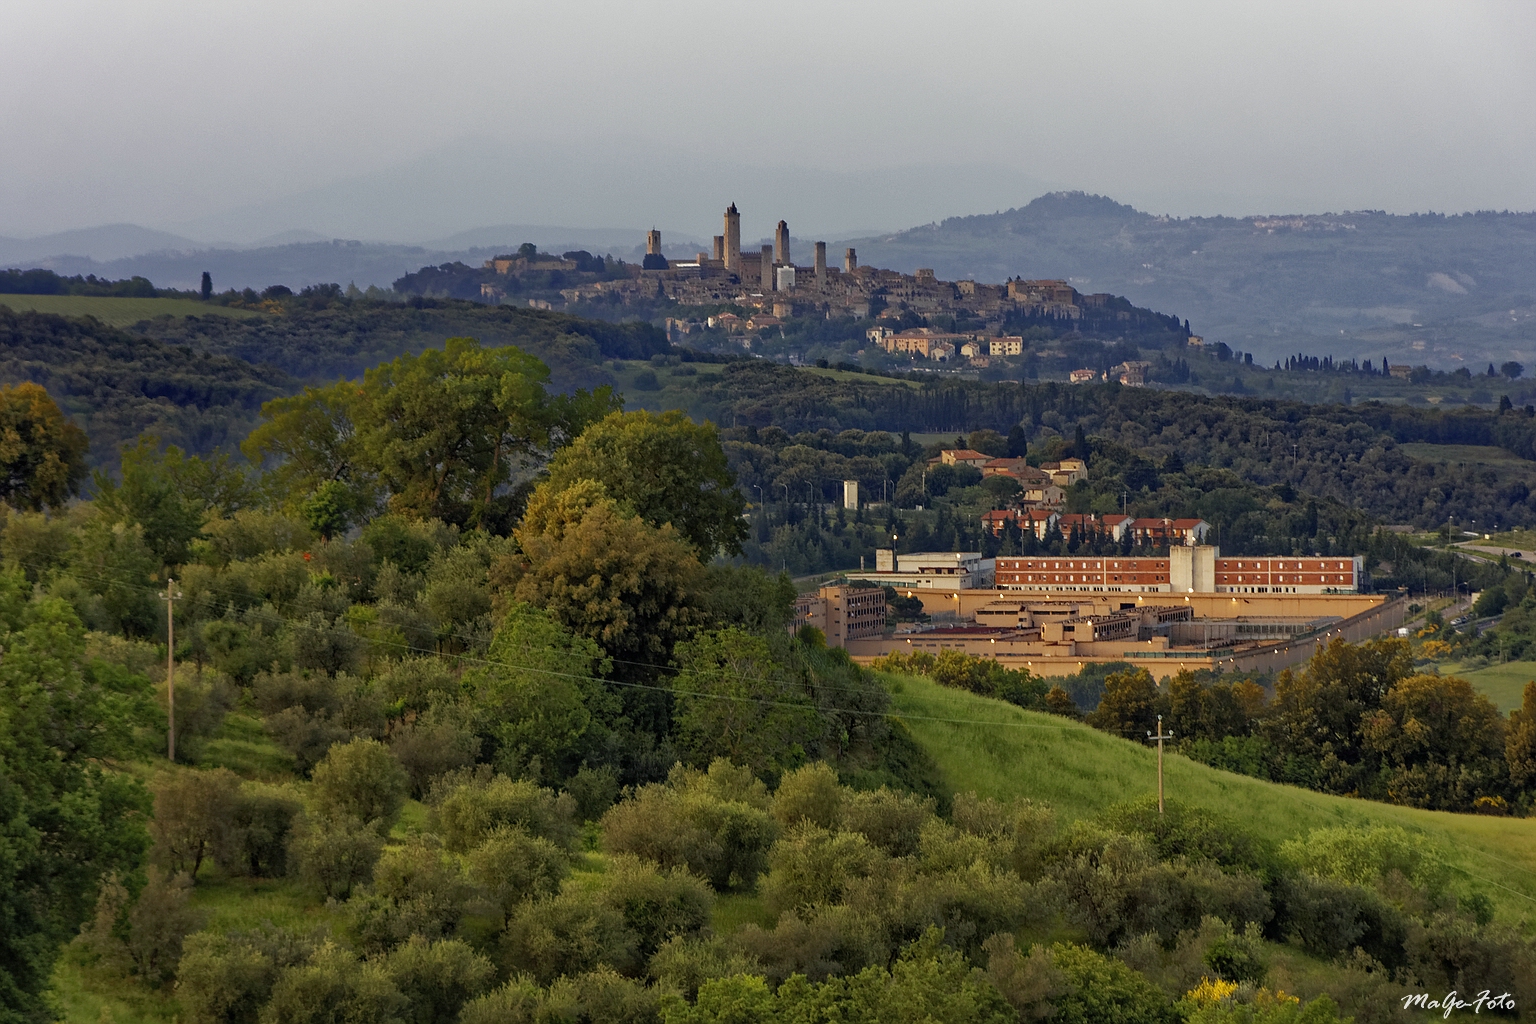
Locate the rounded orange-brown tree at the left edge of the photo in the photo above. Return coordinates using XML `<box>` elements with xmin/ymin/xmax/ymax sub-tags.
<box><xmin>0</xmin><ymin>382</ymin><xmax>91</xmax><ymax>511</ymax></box>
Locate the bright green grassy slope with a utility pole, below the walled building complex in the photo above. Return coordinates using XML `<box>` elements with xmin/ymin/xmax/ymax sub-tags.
<box><xmin>891</xmin><ymin>677</ymin><xmax>1536</xmax><ymax>921</ymax></box>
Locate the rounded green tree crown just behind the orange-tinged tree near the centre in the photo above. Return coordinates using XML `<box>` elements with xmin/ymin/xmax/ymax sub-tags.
<box><xmin>550</xmin><ymin>410</ymin><xmax>746</xmax><ymax>560</ymax></box>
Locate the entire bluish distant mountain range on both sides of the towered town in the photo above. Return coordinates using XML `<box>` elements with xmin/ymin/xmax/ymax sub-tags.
<box><xmin>0</xmin><ymin>192</ymin><xmax>1536</xmax><ymax>372</ymax></box>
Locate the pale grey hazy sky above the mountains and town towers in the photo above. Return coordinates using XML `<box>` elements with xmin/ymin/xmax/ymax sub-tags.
<box><xmin>0</xmin><ymin>0</ymin><xmax>1536</xmax><ymax>238</ymax></box>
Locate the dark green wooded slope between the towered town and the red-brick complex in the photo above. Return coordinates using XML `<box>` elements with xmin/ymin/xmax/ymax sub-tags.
<box><xmin>628</xmin><ymin>361</ymin><xmax>1536</xmax><ymax>536</ymax></box>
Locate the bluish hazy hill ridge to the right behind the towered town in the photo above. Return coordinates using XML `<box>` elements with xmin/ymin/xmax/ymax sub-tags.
<box><xmin>849</xmin><ymin>192</ymin><xmax>1536</xmax><ymax>368</ymax></box>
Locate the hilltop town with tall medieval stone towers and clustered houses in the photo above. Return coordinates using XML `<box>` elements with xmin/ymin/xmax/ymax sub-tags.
<box><xmin>454</xmin><ymin>204</ymin><xmax>1200</xmax><ymax>374</ymax></box>
